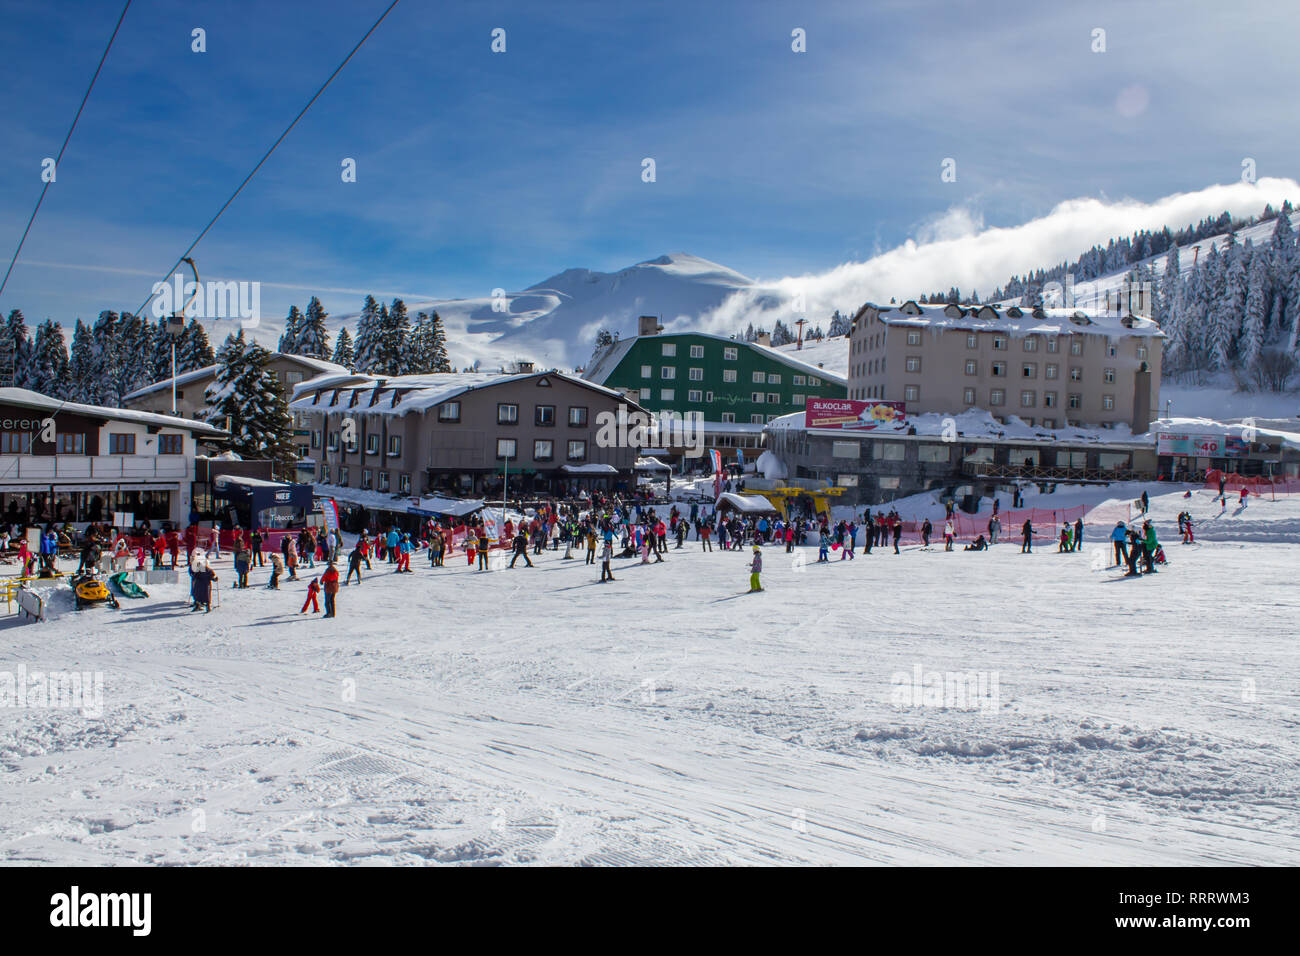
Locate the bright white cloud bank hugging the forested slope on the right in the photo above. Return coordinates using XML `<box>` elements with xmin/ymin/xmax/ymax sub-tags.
<box><xmin>686</xmin><ymin>178</ymin><xmax>1300</xmax><ymax>334</ymax></box>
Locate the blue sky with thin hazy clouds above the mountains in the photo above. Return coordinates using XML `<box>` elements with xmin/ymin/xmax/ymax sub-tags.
<box><xmin>0</xmin><ymin>0</ymin><xmax>1300</xmax><ymax>326</ymax></box>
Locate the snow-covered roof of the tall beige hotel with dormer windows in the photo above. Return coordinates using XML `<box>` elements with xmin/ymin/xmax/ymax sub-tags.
<box><xmin>853</xmin><ymin>300</ymin><xmax>1165</xmax><ymax>338</ymax></box>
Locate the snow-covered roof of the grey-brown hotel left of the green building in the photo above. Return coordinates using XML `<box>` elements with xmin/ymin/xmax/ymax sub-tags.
<box><xmin>289</xmin><ymin>371</ymin><xmax>628</xmax><ymax>415</ymax></box>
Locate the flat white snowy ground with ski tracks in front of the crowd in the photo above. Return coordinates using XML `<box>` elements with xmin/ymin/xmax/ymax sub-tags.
<box><xmin>0</xmin><ymin>485</ymin><xmax>1300</xmax><ymax>865</ymax></box>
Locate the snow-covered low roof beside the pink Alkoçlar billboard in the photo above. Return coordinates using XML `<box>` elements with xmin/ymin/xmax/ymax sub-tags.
<box><xmin>767</xmin><ymin>408</ymin><xmax>1156</xmax><ymax>447</ymax></box>
